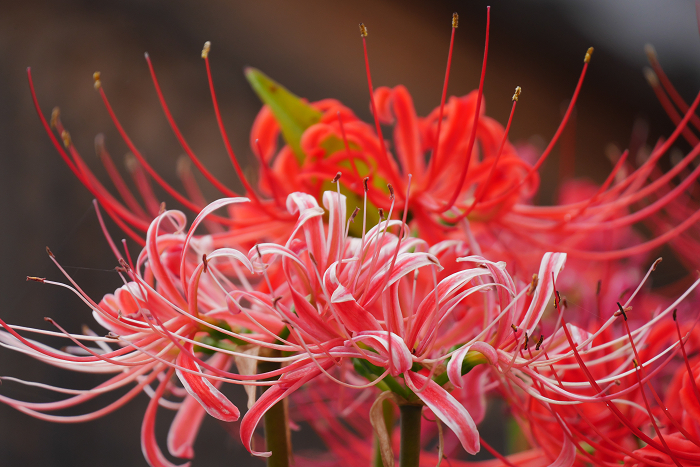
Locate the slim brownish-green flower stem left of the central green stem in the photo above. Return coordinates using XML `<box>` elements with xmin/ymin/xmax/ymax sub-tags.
<box><xmin>258</xmin><ymin>350</ymin><xmax>291</xmax><ymax>467</ymax></box>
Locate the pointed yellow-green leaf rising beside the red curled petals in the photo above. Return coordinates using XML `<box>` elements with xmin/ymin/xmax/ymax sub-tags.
<box><xmin>245</xmin><ymin>67</ymin><xmax>322</xmax><ymax>164</ymax></box>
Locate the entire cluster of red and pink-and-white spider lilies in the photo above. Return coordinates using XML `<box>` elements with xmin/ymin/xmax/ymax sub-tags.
<box><xmin>0</xmin><ymin>7</ymin><xmax>700</xmax><ymax>467</ymax></box>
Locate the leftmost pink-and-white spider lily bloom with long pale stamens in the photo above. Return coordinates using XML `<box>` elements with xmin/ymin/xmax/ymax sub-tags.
<box><xmin>0</xmin><ymin>198</ymin><xmax>298</xmax><ymax>467</ymax></box>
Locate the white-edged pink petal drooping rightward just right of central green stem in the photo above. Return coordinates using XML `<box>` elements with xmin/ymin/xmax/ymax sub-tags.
<box><xmin>404</xmin><ymin>371</ymin><xmax>480</xmax><ymax>454</ymax></box>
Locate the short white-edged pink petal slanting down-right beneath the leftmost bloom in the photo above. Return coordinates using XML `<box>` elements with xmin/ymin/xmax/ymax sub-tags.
<box><xmin>177</xmin><ymin>344</ymin><xmax>241</xmax><ymax>422</ymax></box>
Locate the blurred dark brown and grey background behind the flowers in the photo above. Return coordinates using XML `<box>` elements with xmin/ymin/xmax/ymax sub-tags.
<box><xmin>0</xmin><ymin>0</ymin><xmax>700</xmax><ymax>467</ymax></box>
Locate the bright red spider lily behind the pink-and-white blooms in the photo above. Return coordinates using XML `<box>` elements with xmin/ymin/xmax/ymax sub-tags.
<box><xmin>24</xmin><ymin>11</ymin><xmax>700</xmax><ymax>280</ymax></box>
